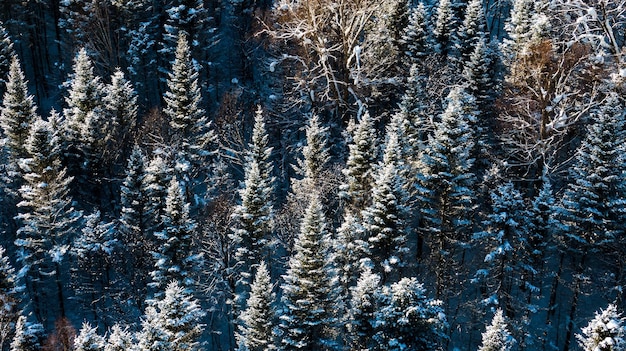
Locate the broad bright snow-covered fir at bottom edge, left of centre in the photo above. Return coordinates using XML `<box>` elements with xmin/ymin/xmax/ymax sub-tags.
<box><xmin>136</xmin><ymin>281</ymin><xmax>205</xmax><ymax>351</ymax></box>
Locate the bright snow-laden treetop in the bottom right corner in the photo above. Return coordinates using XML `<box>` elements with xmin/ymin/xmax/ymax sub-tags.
<box><xmin>576</xmin><ymin>304</ymin><xmax>626</xmax><ymax>351</ymax></box>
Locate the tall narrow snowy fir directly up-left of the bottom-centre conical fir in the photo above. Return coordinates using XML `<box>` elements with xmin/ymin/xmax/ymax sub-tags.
<box><xmin>231</xmin><ymin>107</ymin><xmax>274</xmax><ymax>285</ymax></box>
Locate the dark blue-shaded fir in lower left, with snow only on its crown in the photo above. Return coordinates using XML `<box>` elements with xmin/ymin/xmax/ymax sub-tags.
<box><xmin>71</xmin><ymin>211</ymin><xmax>120</xmax><ymax>324</ymax></box>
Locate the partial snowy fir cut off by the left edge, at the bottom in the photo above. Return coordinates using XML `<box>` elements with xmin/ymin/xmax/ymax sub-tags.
<box><xmin>0</xmin><ymin>246</ymin><xmax>19</xmax><ymax>350</ymax></box>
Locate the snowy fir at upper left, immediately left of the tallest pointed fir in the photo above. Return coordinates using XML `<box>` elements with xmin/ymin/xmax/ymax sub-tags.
<box><xmin>104</xmin><ymin>68</ymin><xmax>138</xmax><ymax>168</ymax></box>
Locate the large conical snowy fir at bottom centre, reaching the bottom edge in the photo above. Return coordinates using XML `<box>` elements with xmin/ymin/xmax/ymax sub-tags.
<box><xmin>279</xmin><ymin>194</ymin><xmax>337</xmax><ymax>351</ymax></box>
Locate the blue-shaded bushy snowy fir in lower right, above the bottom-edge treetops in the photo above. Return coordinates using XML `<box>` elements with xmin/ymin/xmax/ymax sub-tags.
<box><xmin>473</xmin><ymin>182</ymin><xmax>531</xmax><ymax>312</ymax></box>
